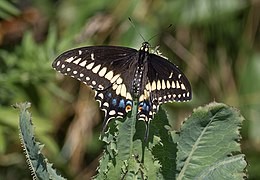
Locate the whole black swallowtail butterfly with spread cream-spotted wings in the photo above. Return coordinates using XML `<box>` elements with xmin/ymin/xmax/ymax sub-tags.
<box><xmin>52</xmin><ymin>42</ymin><xmax>192</xmax><ymax>138</ymax></box>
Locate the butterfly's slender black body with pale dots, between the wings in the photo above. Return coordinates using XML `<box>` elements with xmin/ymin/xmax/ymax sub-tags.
<box><xmin>132</xmin><ymin>42</ymin><xmax>149</xmax><ymax>98</ymax></box>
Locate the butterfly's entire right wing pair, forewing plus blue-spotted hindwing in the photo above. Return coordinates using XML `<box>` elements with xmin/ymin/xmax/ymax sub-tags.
<box><xmin>139</xmin><ymin>54</ymin><xmax>192</xmax><ymax>123</ymax></box>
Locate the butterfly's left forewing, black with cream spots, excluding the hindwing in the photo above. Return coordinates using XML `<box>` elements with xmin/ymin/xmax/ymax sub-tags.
<box><xmin>52</xmin><ymin>46</ymin><xmax>137</xmax><ymax>90</ymax></box>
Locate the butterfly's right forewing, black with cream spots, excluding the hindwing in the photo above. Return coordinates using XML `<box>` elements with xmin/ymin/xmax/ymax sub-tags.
<box><xmin>148</xmin><ymin>54</ymin><xmax>191</xmax><ymax>104</ymax></box>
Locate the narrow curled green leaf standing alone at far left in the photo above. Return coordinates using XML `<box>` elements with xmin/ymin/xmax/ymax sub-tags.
<box><xmin>14</xmin><ymin>103</ymin><xmax>64</xmax><ymax>180</ymax></box>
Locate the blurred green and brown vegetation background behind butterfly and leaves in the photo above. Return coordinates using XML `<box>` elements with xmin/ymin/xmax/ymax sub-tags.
<box><xmin>0</xmin><ymin>0</ymin><xmax>260</xmax><ymax>180</ymax></box>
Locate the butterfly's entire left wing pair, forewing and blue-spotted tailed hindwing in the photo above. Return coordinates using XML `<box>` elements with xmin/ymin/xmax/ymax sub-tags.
<box><xmin>52</xmin><ymin>46</ymin><xmax>138</xmax><ymax>130</ymax></box>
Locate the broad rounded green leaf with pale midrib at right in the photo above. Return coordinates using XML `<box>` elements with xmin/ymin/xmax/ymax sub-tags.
<box><xmin>176</xmin><ymin>103</ymin><xmax>247</xmax><ymax>179</ymax></box>
